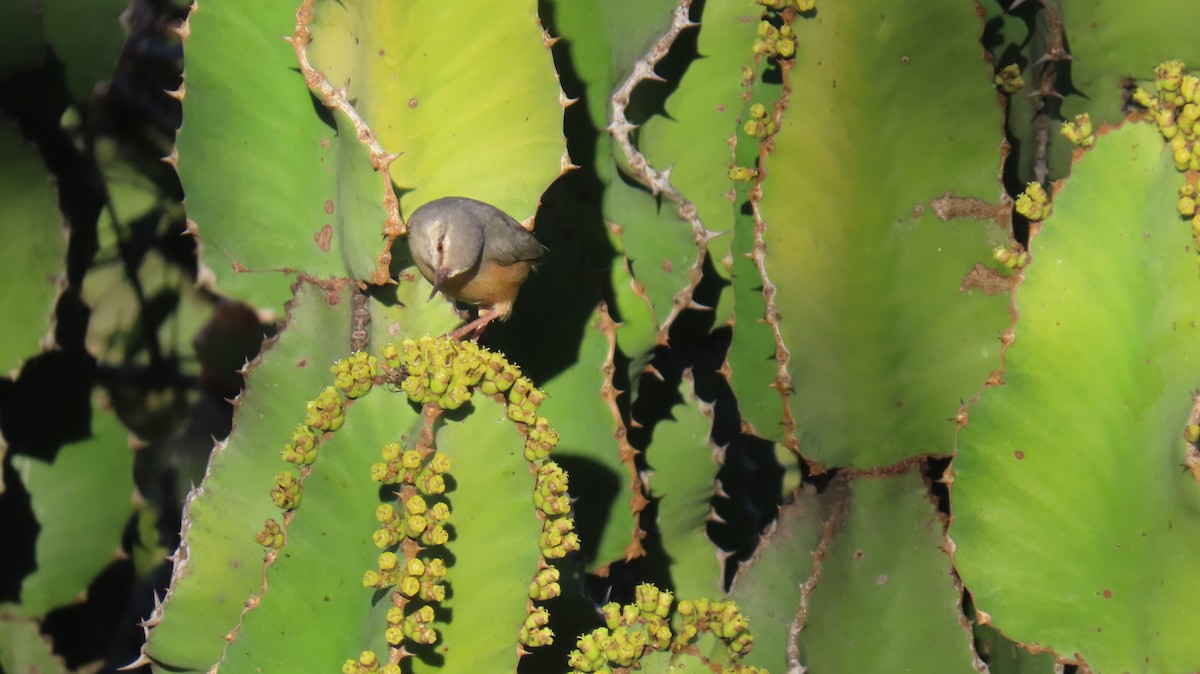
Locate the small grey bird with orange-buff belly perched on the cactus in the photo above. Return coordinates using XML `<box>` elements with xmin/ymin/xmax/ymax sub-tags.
<box><xmin>408</xmin><ymin>197</ymin><xmax>548</xmax><ymax>337</ymax></box>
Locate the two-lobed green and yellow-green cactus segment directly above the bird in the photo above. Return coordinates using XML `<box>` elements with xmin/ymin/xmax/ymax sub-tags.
<box><xmin>179</xmin><ymin>1</ymin><xmax>564</xmax><ymax>302</ymax></box>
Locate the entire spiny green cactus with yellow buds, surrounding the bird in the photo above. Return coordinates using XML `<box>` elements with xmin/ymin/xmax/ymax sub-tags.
<box><xmin>7</xmin><ymin>0</ymin><xmax>1200</xmax><ymax>674</ymax></box>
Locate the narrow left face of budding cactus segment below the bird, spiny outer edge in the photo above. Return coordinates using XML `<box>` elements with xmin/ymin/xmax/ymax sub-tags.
<box><xmin>146</xmin><ymin>277</ymin><xmax>350</xmax><ymax>672</ymax></box>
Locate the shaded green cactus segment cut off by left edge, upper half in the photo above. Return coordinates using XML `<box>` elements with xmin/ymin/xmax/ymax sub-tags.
<box><xmin>0</xmin><ymin>125</ymin><xmax>67</xmax><ymax>372</ymax></box>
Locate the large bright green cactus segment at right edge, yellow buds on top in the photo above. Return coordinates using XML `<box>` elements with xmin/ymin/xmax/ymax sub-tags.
<box><xmin>950</xmin><ymin>125</ymin><xmax>1200</xmax><ymax>672</ymax></box>
